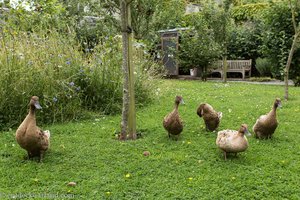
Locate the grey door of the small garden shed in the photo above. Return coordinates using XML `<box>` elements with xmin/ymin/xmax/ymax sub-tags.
<box><xmin>162</xmin><ymin>37</ymin><xmax>178</xmax><ymax>75</ymax></box>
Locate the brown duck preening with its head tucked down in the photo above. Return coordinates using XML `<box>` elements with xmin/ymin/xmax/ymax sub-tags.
<box><xmin>197</xmin><ymin>103</ymin><xmax>222</xmax><ymax>131</ymax></box>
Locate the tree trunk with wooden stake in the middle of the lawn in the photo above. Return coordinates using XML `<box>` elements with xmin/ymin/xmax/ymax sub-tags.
<box><xmin>119</xmin><ymin>0</ymin><xmax>136</xmax><ymax>140</ymax></box>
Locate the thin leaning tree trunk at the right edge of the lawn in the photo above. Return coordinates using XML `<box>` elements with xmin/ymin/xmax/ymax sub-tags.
<box><xmin>284</xmin><ymin>32</ymin><xmax>299</xmax><ymax>100</ymax></box>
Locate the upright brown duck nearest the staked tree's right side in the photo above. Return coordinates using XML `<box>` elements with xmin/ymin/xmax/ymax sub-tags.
<box><xmin>163</xmin><ymin>96</ymin><xmax>184</xmax><ymax>139</ymax></box>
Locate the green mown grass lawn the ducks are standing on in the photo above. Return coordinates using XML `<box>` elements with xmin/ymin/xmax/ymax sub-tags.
<box><xmin>0</xmin><ymin>80</ymin><xmax>300</xmax><ymax>199</ymax></box>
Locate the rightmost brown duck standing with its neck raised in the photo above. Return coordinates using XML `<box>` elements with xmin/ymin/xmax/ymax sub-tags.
<box><xmin>253</xmin><ymin>98</ymin><xmax>282</xmax><ymax>139</ymax></box>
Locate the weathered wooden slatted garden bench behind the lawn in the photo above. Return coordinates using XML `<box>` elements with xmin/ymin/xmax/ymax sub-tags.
<box><xmin>210</xmin><ymin>59</ymin><xmax>252</xmax><ymax>79</ymax></box>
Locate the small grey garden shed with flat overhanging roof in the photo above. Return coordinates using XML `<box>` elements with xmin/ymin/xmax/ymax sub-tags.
<box><xmin>158</xmin><ymin>28</ymin><xmax>187</xmax><ymax>76</ymax></box>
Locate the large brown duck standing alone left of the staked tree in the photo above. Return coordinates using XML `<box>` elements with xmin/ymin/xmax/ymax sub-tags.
<box><xmin>16</xmin><ymin>96</ymin><xmax>50</xmax><ymax>162</ymax></box>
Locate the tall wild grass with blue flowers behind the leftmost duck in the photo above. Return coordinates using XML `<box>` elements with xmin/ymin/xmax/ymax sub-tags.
<box><xmin>0</xmin><ymin>29</ymin><xmax>161</xmax><ymax>129</ymax></box>
